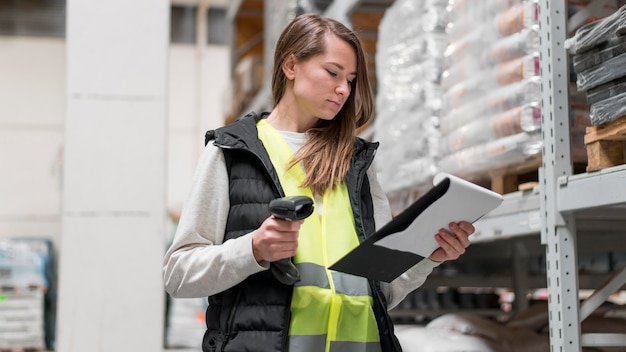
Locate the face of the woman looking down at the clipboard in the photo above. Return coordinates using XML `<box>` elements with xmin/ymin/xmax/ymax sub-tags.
<box><xmin>293</xmin><ymin>34</ymin><xmax>356</xmax><ymax>120</ymax></box>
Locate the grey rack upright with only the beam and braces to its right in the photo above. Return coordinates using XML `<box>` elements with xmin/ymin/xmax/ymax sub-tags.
<box><xmin>539</xmin><ymin>0</ymin><xmax>626</xmax><ymax>351</ymax></box>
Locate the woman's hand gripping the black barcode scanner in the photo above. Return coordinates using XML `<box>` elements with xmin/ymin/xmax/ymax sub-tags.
<box><xmin>252</xmin><ymin>216</ymin><xmax>304</xmax><ymax>263</ymax></box>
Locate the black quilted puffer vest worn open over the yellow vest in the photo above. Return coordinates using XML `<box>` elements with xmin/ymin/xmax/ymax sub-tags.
<box><xmin>202</xmin><ymin>113</ymin><xmax>401</xmax><ymax>352</ymax></box>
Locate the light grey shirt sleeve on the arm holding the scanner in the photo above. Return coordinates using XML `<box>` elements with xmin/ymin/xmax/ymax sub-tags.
<box><xmin>163</xmin><ymin>143</ymin><xmax>267</xmax><ymax>298</ymax></box>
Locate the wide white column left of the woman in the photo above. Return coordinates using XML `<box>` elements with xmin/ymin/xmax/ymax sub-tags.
<box><xmin>57</xmin><ymin>0</ymin><xmax>169</xmax><ymax>352</ymax></box>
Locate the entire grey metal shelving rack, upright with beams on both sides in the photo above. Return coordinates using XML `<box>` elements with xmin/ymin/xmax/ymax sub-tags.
<box><xmin>474</xmin><ymin>0</ymin><xmax>626</xmax><ymax>352</ymax></box>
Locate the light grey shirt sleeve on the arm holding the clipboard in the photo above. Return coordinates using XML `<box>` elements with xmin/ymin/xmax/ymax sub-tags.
<box><xmin>367</xmin><ymin>167</ymin><xmax>439</xmax><ymax>310</ymax></box>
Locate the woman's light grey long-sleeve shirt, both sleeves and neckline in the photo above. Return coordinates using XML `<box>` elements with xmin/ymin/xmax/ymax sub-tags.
<box><xmin>163</xmin><ymin>131</ymin><xmax>438</xmax><ymax>309</ymax></box>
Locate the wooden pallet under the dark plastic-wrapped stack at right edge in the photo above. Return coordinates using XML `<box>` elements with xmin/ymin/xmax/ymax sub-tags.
<box><xmin>585</xmin><ymin>116</ymin><xmax>626</xmax><ymax>172</ymax></box>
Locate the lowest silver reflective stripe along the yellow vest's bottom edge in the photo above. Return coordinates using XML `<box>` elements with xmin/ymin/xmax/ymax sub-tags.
<box><xmin>288</xmin><ymin>335</ymin><xmax>382</xmax><ymax>352</ymax></box>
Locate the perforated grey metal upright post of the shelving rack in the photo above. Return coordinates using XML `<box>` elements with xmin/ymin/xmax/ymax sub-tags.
<box><xmin>539</xmin><ymin>0</ymin><xmax>581</xmax><ymax>352</ymax></box>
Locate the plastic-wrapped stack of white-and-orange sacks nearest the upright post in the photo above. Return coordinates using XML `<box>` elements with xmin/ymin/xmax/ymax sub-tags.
<box><xmin>440</xmin><ymin>0</ymin><xmax>542</xmax><ymax>176</ymax></box>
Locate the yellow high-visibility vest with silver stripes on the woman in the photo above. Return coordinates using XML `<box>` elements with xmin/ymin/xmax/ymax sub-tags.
<box><xmin>257</xmin><ymin>119</ymin><xmax>381</xmax><ymax>352</ymax></box>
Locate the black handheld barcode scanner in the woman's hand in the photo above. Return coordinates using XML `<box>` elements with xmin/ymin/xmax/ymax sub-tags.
<box><xmin>269</xmin><ymin>196</ymin><xmax>314</xmax><ymax>285</ymax></box>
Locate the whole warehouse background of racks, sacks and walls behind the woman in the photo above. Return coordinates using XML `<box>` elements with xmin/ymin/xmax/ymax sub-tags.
<box><xmin>0</xmin><ymin>0</ymin><xmax>626</xmax><ymax>352</ymax></box>
